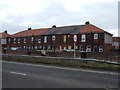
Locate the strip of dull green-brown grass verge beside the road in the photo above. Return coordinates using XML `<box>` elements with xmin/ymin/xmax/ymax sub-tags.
<box><xmin>2</xmin><ymin>56</ymin><xmax>120</xmax><ymax>71</ymax></box>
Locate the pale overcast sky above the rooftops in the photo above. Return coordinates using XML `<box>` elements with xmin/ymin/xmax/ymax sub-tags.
<box><xmin>0</xmin><ymin>0</ymin><xmax>119</xmax><ymax>36</ymax></box>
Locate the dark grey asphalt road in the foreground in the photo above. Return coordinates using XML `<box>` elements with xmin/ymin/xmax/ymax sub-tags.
<box><xmin>2</xmin><ymin>61</ymin><xmax>118</xmax><ymax>88</ymax></box>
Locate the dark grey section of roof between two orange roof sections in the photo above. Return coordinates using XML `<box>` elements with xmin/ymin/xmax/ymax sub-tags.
<box><xmin>44</xmin><ymin>25</ymin><xmax>85</xmax><ymax>35</ymax></box>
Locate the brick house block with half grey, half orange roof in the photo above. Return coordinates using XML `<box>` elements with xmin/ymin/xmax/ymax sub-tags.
<box><xmin>43</xmin><ymin>22</ymin><xmax>112</xmax><ymax>52</ymax></box>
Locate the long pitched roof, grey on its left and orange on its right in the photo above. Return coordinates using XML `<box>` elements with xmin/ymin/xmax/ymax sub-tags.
<box><xmin>44</xmin><ymin>24</ymin><xmax>112</xmax><ymax>35</ymax></box>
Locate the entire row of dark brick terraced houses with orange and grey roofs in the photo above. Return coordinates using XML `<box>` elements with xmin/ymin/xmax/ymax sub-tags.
<box><xmin>0</xmin><ymin>22</ymin><xmax>120</xmax><ymax>52</ymax></box>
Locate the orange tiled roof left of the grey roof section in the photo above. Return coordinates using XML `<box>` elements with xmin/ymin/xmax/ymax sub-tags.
<box><xmin>11</xmin><ymin>28</ymin><xmax>49</xmax><ymax>37</ymax></box>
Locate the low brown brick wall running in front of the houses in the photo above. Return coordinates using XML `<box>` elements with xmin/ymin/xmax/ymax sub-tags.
<box><xmin>2</xmin><ymin>50</ymin><xmax>120</xmax><ymax>62</ymax></box>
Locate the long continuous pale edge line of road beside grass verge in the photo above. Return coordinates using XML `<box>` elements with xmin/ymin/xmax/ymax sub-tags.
<box><xmin>2</xmin><ymin>61</ymin><xmax>119</xmax><ymax>75</ymax></box>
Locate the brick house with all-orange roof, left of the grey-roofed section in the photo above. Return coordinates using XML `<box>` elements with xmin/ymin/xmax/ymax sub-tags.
<box><xmin>9</xmin><ymin>28</ymin><xmax>49</xmax><ymax>50</ymax></box>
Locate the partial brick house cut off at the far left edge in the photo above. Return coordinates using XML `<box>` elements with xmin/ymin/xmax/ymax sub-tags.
<box><xmin>0</xmin><ymin>31</ymin><xmax>10</xmax><ymax>49</ymax></box>
